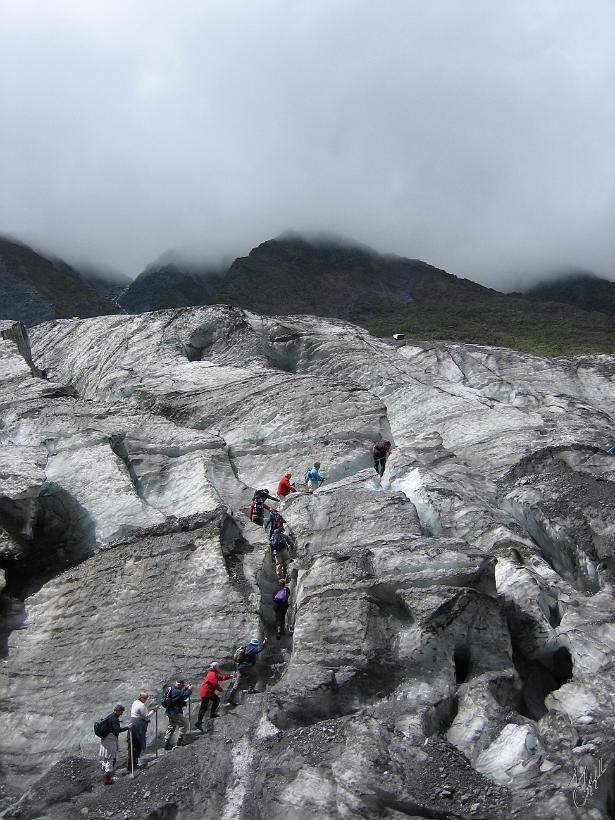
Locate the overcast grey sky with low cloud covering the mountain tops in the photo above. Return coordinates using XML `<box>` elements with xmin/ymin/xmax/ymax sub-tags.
<box><xmin>0</xmin><ymin>0</ymin><xmax>615</xmax><ymax>289</ymax></box>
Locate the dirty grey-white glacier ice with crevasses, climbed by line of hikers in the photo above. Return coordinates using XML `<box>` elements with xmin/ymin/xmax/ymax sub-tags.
<box><xmin>0</xmin><ymin>306</ymin><xmax>615</xmax><ymax>820</ymax></box>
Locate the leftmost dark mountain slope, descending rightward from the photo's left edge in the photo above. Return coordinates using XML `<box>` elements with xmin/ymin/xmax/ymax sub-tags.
<box><xmin>0</xmin><ymin>237</ymin><xmax>119</xmax><ymax>325</ymax></box>
